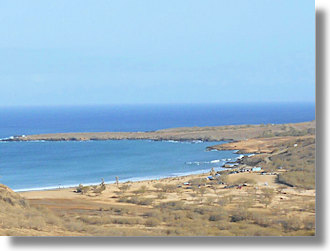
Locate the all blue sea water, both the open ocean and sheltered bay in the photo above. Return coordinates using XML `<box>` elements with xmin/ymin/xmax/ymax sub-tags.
<box><xmin>0</xmin><ymin>103</ymin><xmax>315</xmax><ymax>190</ymax></box>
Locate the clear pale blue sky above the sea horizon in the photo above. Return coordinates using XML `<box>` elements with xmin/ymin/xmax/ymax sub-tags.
<box><xmin>0</xmin><ymin>0</ymin><xmax>315</xmax><ymax>106</ymax></box>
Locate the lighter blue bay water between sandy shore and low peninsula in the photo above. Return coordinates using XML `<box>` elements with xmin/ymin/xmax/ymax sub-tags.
<box><xmin>0</xmin><ymin>140</ymin><xmax>239</xmax><ymax>190</ymax></box>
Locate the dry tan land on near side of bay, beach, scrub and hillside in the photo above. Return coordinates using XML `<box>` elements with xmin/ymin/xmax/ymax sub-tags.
<box><xmin>0</xmin><ymin>122</ymin><xmax>315</xmax><ymax>236</ymax></box>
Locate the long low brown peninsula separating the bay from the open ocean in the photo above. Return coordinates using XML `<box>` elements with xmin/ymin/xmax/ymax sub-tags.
<box><xmin>1</xmin><ymin>121</ymin><xmax>315</xmax><ymax>141</ymax></box>
